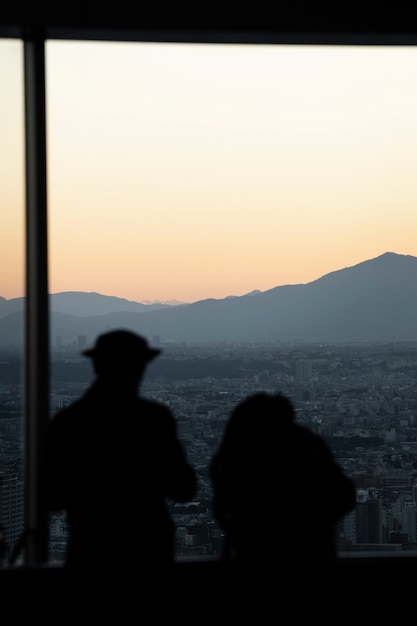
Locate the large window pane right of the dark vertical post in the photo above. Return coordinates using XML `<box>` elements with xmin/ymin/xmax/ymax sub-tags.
<box><xmin>46</xmin><ymin>41</ymin><xmax>417</xmax><ymax>559</ymax></box>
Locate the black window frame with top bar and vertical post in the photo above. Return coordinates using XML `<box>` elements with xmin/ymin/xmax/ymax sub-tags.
<box><xmin>0</xmin><ymin>17</ymin><xmax>417</xmax><ymax>566</ymax></box>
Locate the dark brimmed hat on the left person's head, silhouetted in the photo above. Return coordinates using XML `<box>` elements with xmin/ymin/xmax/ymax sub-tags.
<box><xmin>82</xmin><ymin>330</ymin><xmax>161</xmax><ymax>366</ymax></box>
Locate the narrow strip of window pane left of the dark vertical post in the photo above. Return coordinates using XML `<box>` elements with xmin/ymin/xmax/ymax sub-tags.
<box><xmin>0</xmin><ymin>39</ymin><xmax>25</xmax><ymax>566</ymax></box>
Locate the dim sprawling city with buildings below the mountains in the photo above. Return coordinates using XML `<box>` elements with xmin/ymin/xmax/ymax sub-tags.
<box><xmin>0</xmin><ymin>336</ymin><xmax>417</xmax><ymax>563</ymax></box>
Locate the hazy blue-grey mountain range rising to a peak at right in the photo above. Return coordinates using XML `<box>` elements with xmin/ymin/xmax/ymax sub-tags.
<box><xmin>0</xmin><ymin>252</ymin><xmax>417</xmax><ymax>347</ymax></box>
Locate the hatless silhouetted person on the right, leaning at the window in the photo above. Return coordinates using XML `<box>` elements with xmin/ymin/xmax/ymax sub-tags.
<box><xmin>210</xmin><ymin>393</ymin><xmax>356</xmax><ymax>624</ymax></box>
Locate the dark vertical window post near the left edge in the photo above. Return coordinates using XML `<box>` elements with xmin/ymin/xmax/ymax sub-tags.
<box><xmin>24</xmin><ymin>34</ymin><xmax>49</xmax><ymax>565</ymax></box>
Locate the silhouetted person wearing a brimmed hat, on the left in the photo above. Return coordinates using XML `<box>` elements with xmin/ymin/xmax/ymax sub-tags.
<box><xmin>44</xmin><ymin>329</ymin><xmax>197</xmax><ymax>592</ymax></box>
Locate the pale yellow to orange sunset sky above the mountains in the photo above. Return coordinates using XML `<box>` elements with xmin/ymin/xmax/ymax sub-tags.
<box><xmin>0</xmin><ymin>40</ymin><xmax>417</xmax><ymax>302</ymax></box>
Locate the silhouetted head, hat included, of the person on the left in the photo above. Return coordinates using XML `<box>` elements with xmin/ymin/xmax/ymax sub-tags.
<box><xmin>83</xmin><ymin>329</ymin><xmax>161</xmax><ymax>378</ymax></box>
